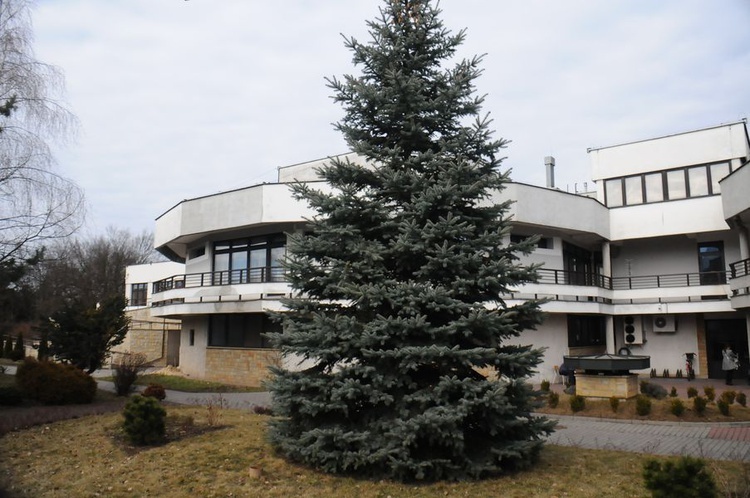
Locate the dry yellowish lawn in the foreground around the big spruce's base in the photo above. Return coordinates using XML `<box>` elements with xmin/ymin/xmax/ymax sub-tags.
<box><xmin>0</xmin><ymin>406</ymin><xmax>743</xmax><ymax>498</ymax></box>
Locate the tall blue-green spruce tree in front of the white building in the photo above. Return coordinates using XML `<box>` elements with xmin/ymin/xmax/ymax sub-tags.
<box><xmin>269</xmin><ymin>0</ymin><xmax>553</xmax><ymax>480</ymax></box>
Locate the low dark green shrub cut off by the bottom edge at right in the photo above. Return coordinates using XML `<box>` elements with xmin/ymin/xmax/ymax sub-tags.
<box><xmin>643</xmin><ymin>456</ymin><xmax>718</xmax><ymax>498</ymax></box>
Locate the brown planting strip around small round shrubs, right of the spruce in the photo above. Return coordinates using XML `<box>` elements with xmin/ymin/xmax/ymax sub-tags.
<box><xmin>537</xmin><ymin>392</ymin><xmax>750</xmax><ymax>422</ymax></box>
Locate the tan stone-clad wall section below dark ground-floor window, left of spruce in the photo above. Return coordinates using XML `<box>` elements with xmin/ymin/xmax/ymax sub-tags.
<box><xmin>206</xmin><ymin>348</ymin><xmax>279</xmax><ymax>387</ymax></box>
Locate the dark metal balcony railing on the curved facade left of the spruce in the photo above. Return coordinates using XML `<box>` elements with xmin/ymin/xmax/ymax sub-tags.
<box><xmin>153</xmin><ymin>266</ymin><xmax>285</xmax><ymax>293</ymax></box>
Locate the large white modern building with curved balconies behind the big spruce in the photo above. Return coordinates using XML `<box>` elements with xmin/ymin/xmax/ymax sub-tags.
<box><xmin>151</xmin><ymin>120</ymin><xmax>750</xmax><ymax>385</ymax></box>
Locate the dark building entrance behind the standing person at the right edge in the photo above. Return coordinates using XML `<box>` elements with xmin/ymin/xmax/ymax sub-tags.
<box><xmin>705</xmin><ymin>318</ymin><xmax>750</xmax><ymax>379</ymax></box>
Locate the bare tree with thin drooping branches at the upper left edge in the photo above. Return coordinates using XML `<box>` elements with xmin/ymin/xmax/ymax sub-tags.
<box><xmin>0</xmin><ymin>0</ymin><xmax>85</xmax><ymax>262</ymax></box>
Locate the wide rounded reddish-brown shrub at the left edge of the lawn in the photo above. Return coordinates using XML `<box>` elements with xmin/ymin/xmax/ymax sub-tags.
<box><xmin>16</xmin><ymin>357</ymin><xmax>96</xmax><ymax>405</ymax></box>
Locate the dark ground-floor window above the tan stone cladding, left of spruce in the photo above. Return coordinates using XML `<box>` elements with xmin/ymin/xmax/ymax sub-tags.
<box><xmin>208</xmin><ymin>313</ymin><xmax>281</xmax><ymax>348</ymax></box>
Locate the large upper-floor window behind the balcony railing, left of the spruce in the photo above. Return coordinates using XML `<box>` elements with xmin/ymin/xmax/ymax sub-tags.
<box><xmin>213</xmin><ymin>234</ymin><xmax>286</xmax><ymax>285</ymax></box>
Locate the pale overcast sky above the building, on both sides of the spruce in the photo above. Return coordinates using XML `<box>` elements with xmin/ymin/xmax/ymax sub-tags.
<box><xmin>33</xmin><ymin>0</ymin><xmax>750</xmax><ymax>233</ymax></box>
